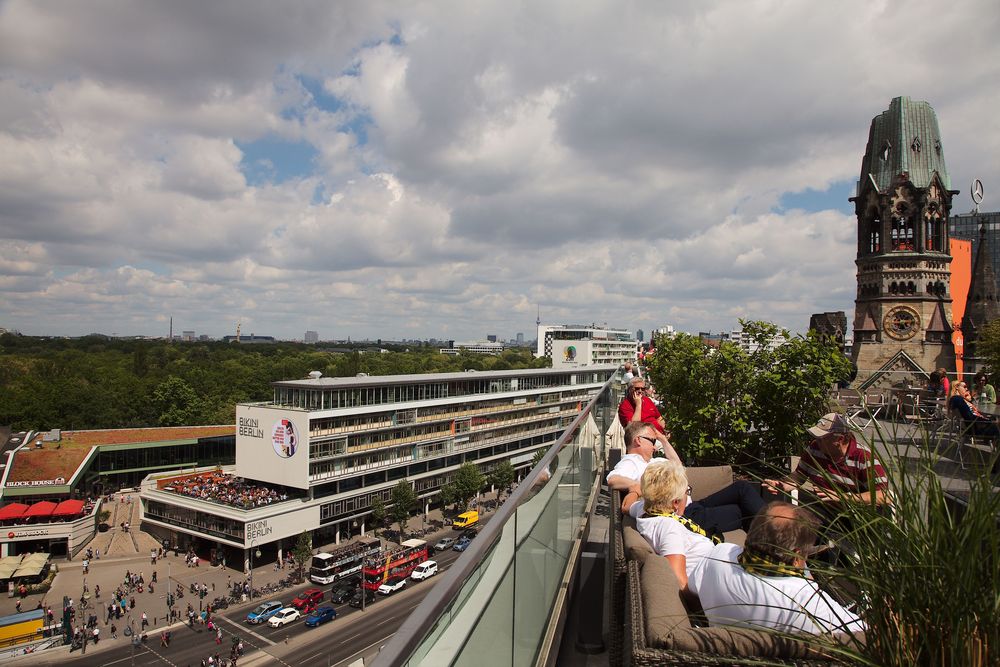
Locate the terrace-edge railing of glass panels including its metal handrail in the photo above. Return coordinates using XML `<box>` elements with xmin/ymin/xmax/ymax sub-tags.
<box><xmin>374</xmin><ymin>374</ymin><xmax>621</xmax><ymax>667</ymax></box>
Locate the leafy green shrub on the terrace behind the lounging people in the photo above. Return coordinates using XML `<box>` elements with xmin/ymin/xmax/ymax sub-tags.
<box><xmin>647</xmin><ymin>320</ymin><xmax>850</xmax><ymax>463</ymax></box>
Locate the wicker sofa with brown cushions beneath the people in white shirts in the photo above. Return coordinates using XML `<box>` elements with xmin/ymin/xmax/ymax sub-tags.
<box><xmin>609</xmin><ymin>466</ymin><xmax>852</xmax><ymax>665</ymax></box>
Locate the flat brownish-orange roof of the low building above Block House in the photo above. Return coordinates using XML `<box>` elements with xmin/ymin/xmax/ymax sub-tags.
<box><xmin>7</xmin><ymin>424</ymin><xmax>236</xmax><ymax>483</ymax></box>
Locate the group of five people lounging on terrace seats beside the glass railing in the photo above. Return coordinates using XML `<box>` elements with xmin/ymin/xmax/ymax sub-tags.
<box><xmin>607</xmin><ymin>377</ymin><xmax>889</xmax><ymax>634</ymax></box>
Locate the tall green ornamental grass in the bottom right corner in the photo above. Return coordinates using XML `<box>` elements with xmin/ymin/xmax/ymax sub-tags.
<box><xmin>780</xmin><ymin>434</ymin><xmax>1000</xmax><ymax>667</ymax></box>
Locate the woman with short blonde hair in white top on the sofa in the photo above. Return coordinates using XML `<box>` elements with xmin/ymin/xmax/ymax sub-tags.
<box><xmin>636</xmin><ymin>459</ymin><xmax>721</xmax><ymax>592</ymax></box>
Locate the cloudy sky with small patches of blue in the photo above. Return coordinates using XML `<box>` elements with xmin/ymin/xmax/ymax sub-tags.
<box><xmin>0</xmin><ymin>0</ymin><xmax>1000</xmax><ymax>341</ymax></box>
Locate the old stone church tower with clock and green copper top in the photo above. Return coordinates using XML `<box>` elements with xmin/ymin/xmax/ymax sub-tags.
<box><xmin>851</xmin><ymin>97</ymin><xmax>958</xmax><ymax>389</ymax></box>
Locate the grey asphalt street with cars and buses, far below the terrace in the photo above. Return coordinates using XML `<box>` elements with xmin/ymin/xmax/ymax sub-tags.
<box><xmin>47</xmin><ymin>544</ymin><xmax>460</xmax><ymax>667</ymax></box>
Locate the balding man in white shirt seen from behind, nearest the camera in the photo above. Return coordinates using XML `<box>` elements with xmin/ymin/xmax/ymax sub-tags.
<box><xmin>688</xmin><ymin>502</ymin><xmax>865</xmax><ymax>634</ymax></box>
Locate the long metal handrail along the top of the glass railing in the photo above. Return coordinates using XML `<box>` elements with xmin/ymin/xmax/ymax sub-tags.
<box><xmin>372</xmin><ymin>373</ymin><xmax>618</xmax><ymax>667</ymax></box>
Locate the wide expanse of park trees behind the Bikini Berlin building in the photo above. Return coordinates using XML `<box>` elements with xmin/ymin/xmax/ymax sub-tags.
<box><xmin>0</xmin><ymin>333</ymin><xmax>544</xmax><ymax>430</ymax></box>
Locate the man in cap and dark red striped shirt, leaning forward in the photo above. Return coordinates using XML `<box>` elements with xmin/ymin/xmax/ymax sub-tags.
<box><xmin>764</xmin><ymin>412</ymin><xmax>889</xmax><ymax>505</ymax></box>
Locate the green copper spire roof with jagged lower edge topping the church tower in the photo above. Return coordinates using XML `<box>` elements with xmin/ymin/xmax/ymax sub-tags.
<box><xmin>858</xmin><ymin>97</ymin><xmax>951</xmax><ymax>194</ymax></box>
